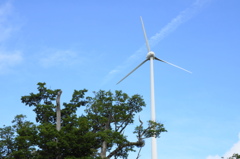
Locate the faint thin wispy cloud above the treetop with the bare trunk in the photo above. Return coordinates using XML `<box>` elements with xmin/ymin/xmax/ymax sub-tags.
<box><xmin>39</xmin><ymin>49</ymin><xmax>84</xmax><ymax>68</ymax></box>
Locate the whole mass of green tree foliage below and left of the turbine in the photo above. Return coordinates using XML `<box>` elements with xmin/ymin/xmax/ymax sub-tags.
<box><xmin>0</xmin><ymin>83</ymin><xmax>166</xmax><ymax>159</ymax></box>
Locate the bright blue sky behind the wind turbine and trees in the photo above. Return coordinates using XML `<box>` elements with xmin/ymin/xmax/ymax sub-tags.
<box><xmin>0</xmin><ymin>0</ymin><xmax>240</xmax><ymax>159</ymax></box>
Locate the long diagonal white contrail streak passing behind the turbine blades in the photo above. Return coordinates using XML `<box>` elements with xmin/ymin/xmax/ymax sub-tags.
<box><xmin>103</xmin><ymin>0</ymin><xmax>211</xmax><ymax>85</ymax></box>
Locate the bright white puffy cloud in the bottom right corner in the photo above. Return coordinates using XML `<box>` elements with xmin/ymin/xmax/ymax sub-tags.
<box><xmin>206</xmin><ymin>133</ymin><xmax>240</xmax><ymax>159</ymax></box>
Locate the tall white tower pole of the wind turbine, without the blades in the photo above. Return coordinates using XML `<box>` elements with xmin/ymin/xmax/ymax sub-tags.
<box><xmin>150</xmin><ymin>56</ymin><xmax>157</xmax><ymax>159</ymax></box>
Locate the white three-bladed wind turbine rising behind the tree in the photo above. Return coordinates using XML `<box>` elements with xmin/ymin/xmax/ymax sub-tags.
<box><xmin>117</xmin><ymin>17</ymin><xmax>191</xmax><ymax>159</ymax></box>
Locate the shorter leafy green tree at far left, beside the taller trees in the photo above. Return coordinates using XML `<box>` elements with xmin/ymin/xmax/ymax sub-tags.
<box><xmin>0</xmin><ymin>115</ymin><xmax>37</xmax><ymax>158</ymax></box>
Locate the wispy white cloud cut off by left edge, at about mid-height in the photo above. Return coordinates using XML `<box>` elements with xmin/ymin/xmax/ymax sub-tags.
<box><xmin>0</xmin><ymin>51</ymin><xmax>23</xmax><ymax>74</ymax></box>
